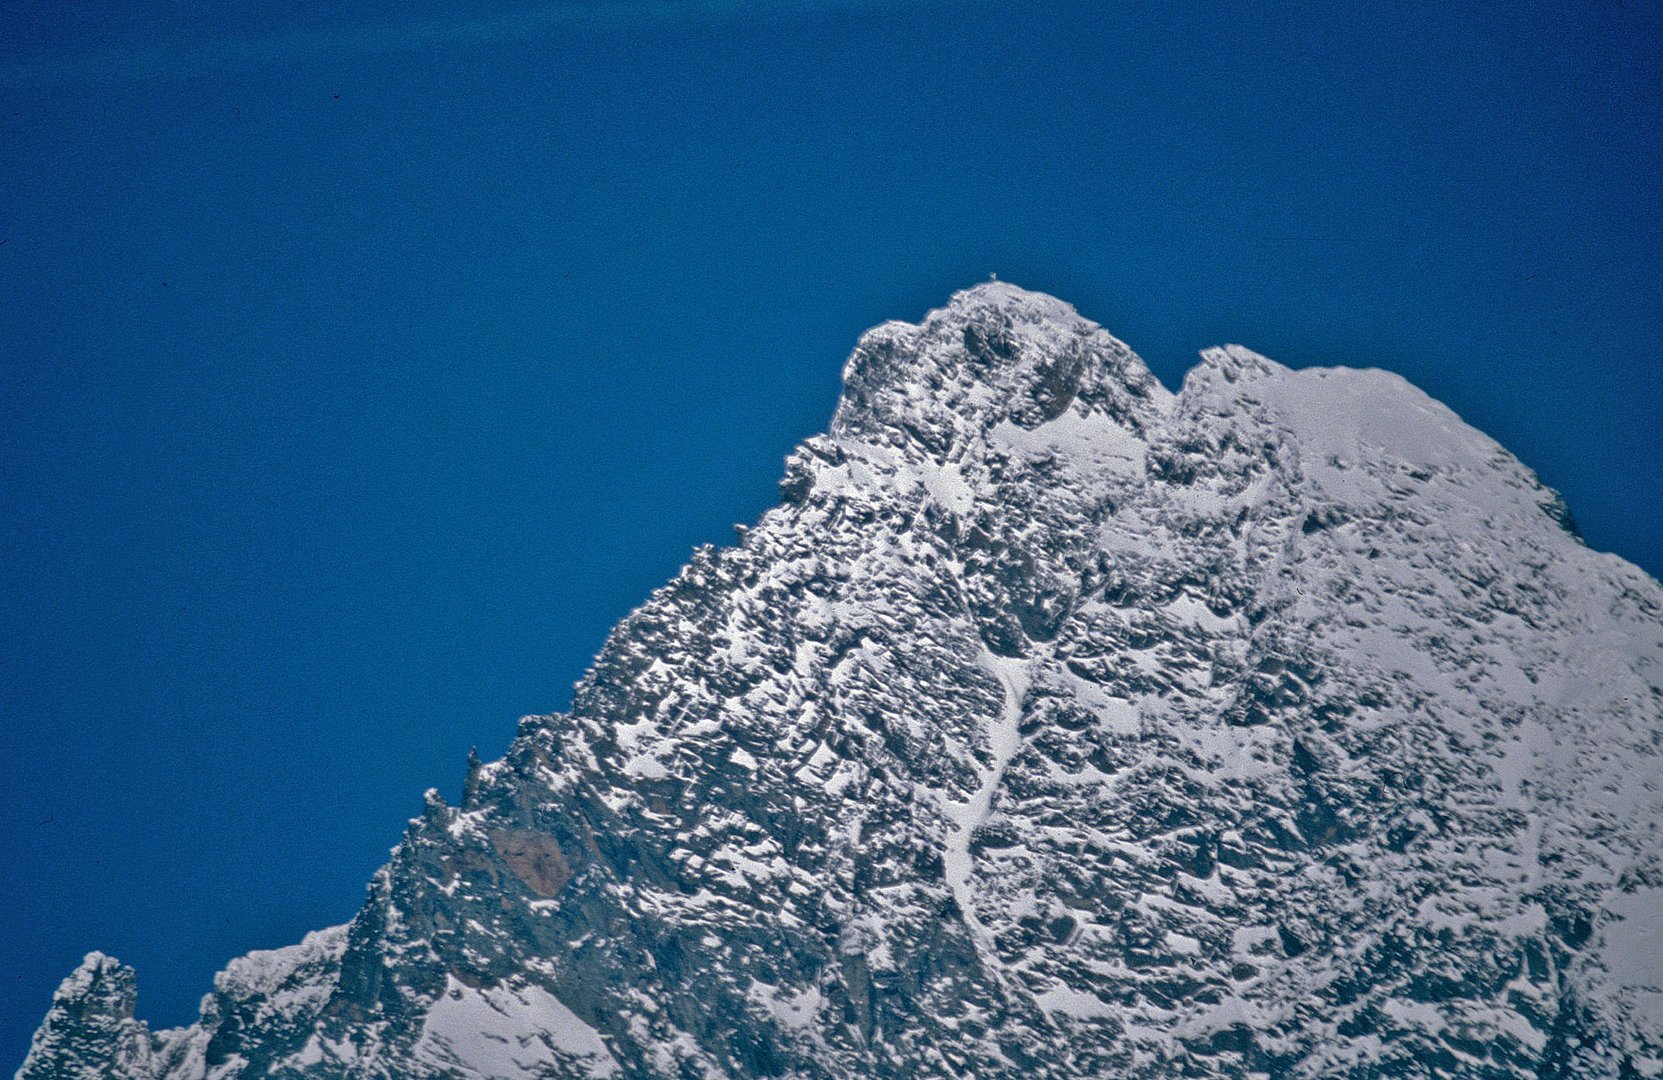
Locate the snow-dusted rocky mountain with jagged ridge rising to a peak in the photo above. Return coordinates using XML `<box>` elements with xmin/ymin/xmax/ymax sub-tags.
<box><xmin>20</xmin><ymin>285</ymin><xmax>1663</xmax><ymax>1080</ymax></box>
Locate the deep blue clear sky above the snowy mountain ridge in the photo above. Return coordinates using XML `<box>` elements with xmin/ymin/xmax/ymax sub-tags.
<box><xmin>0</xmin><ymin>0</ymin><xmax>1663</xmax><ymax>1068</ymax></box>
